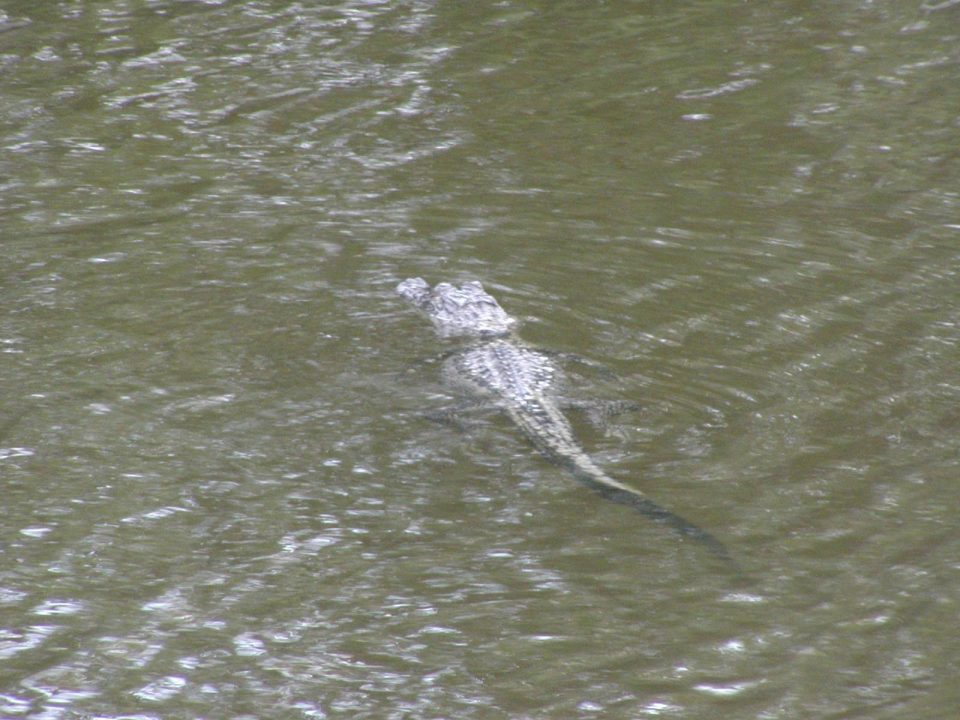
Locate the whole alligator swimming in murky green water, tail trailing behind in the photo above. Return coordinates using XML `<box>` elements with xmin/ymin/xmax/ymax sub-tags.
<box><xmin>397</xmin><ymin>277</ymin><xmax>730</xmax><ymax>560</ymax></box>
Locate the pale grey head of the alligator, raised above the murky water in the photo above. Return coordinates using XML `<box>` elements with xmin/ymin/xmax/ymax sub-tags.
<box><xmin>397</xmin><ymin>278</ymin><xmax>517</xmax><ymax>337</ymax></box>
